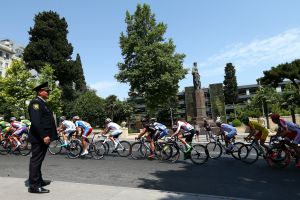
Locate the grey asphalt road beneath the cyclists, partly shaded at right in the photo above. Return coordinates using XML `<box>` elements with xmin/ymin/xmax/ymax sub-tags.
<box><xmin>0</xmin><ymin>152</ymin><xmax>300</xmax><ymax>200</ymax></box>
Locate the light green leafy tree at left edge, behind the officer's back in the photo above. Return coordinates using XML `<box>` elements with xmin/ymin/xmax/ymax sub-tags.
<box><xmin>0</xmin><ymin>60</ymin><xmax>35</xmax><ymax>116</ymax></box>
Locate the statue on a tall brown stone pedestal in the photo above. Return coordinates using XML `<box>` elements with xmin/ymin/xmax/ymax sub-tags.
<box><xmin>192</xmin><ymin>62</ymin><xmax>206</xmax><ymax>125</ymax></box>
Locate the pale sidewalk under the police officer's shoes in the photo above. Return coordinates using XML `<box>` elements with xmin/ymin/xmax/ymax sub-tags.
<box><xmin>0</xmin><ymin>177</ymin><xmax>253</xmax><ymax>200</ymax></box>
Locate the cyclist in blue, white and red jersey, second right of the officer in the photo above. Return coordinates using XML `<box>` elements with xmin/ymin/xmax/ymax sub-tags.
<box><xmin>73</xmin><ymin>116</ymin><xmax>93</xmax><ymax>156</ymax></box>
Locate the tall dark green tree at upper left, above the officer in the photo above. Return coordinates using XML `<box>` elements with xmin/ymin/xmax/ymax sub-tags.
<box><xmin>23</xmin><ymin>11</ymin><xmax>76</xmax><ymax>104</ymax></box>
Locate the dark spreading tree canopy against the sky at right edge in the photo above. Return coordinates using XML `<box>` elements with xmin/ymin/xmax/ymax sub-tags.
<box><xmin>257</xmin><ymin>59</ymin><xmax>300</xmax><ymax>94</ymax></box>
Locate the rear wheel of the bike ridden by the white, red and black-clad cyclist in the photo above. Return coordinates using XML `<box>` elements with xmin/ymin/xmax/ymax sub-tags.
<box><xmin>190</xmin><ymin>144</ymin><xmax>209</xmax><ymax>165</ymax></box>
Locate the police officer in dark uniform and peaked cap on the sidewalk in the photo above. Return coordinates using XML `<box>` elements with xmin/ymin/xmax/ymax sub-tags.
<box><xmin>28</xmin><ymin>82</ymin><xmax>57</xmax><ymax>193</ymax></box>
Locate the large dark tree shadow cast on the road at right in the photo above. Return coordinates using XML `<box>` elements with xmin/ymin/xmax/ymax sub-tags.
<box><xmin>139</xmin><ymin>158</ymin><xmax>300</xmax><ymax>200</ymax></box>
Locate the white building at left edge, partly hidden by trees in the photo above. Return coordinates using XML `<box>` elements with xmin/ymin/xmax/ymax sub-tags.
<box><xmin>0</xmin><ymin>39</ymin><xmax>24</xmax><ymax>77</ymax></box>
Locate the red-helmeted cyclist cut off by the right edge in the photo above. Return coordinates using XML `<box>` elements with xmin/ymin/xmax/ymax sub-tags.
<box><xmin>270</xmin><ymin>113</ymin><xmax>300</xmax><ymax>167</ymax></box>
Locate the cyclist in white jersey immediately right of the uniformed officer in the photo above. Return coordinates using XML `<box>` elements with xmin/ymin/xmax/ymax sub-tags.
<box><xmin>57</xmin><ymin>116</ymin><xmax>76</xmax><ymax>147</ymax></box>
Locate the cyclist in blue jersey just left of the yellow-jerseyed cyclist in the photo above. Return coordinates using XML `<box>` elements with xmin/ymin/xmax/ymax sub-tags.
<box><xmin>216</xmin><ymin>119</ymin><xmax>237</xmax><ymax>153</ymax></box>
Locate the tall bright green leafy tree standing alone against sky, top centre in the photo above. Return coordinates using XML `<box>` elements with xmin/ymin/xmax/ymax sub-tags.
<box><xmin>115</xmin><ymin>4</ymin><xmax>187</xmax><ymax>111</ymax></box>
